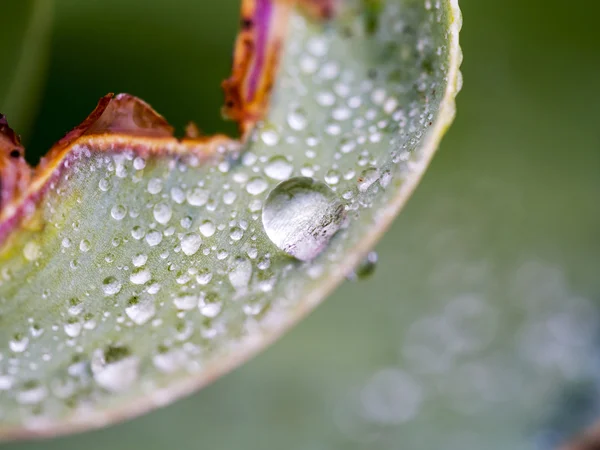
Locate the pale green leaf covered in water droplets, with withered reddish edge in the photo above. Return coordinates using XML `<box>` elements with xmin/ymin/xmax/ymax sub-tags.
<box><xmin>0</xmin><ymin>0</ymin><xmax>460</xmax><ymax>437</ymax></box>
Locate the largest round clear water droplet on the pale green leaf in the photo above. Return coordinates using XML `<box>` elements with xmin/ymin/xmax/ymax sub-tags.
<box><xmin>262</xmin><ymin>177</ymin><xmax>346</xmax><ymax>261</ymax></box>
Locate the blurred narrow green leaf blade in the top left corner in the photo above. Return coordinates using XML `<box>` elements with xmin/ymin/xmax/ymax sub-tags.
<box><xmin>0</xmin><ymin>0</ymin><xmax>52</xmax><ymax>136</ymax></box>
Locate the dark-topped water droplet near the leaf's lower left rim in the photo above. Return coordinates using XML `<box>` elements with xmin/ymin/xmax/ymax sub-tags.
<box><xmin>90</xmin><ymin>346</ymin><xmax>140</xmax><ymax>392</ymax></box>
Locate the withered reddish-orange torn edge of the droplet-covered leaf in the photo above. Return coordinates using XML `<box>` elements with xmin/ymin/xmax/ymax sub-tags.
<box><xmin>0</xmin><ymin>0</ymin><xmax>338</xmax><ymax>253</ymax></box>
